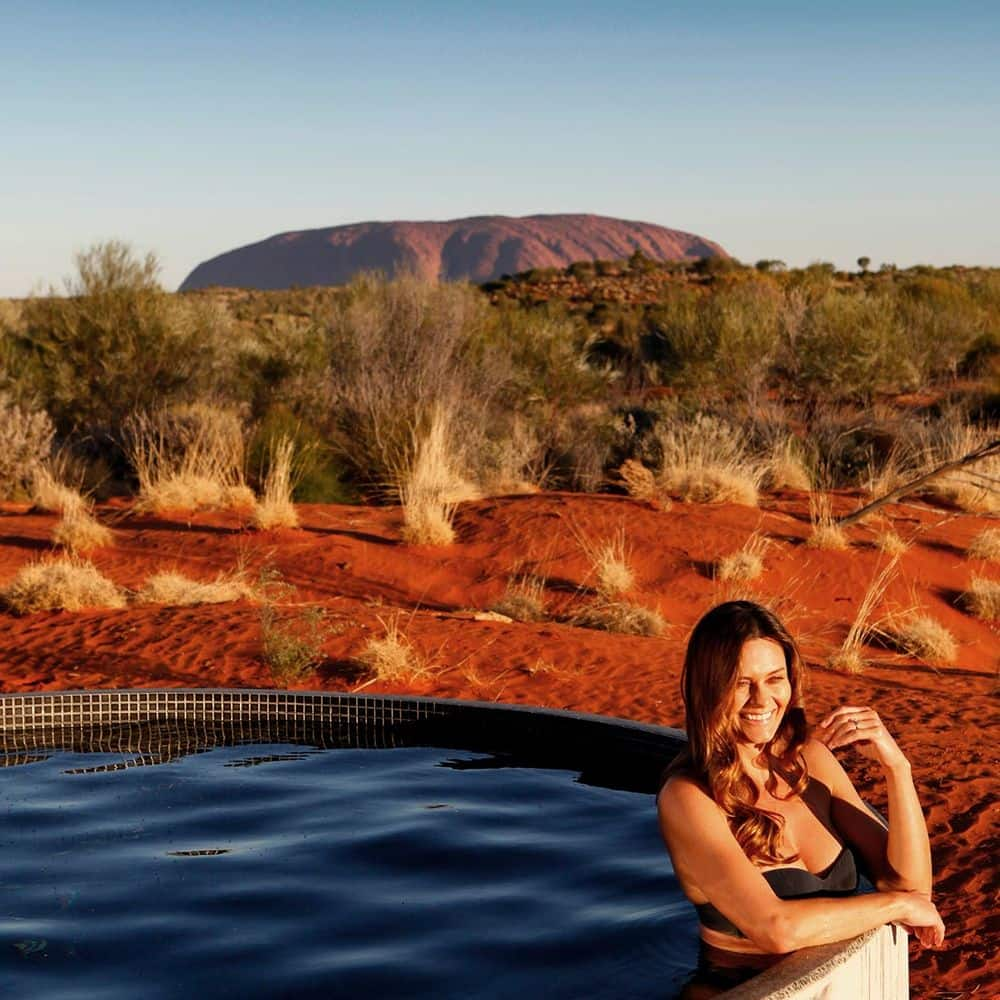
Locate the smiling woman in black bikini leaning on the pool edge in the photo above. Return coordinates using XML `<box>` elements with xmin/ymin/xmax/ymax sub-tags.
<box><xmin>658</xmin><ymin>601</ymin><xmax>944</xmax><ymax>967</ymax></box>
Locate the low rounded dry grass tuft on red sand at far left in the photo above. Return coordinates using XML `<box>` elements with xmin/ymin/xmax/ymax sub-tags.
<box><xmin>0</xmin><ymin>556</ymin><xmax>125</xmax><ymax>614</ymax></box>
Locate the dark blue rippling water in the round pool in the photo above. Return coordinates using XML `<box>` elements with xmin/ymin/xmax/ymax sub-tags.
<box><xmin>0</xmin><ymin>745</ymin><xmax>697</xmax><ymax>1000</ymax></box>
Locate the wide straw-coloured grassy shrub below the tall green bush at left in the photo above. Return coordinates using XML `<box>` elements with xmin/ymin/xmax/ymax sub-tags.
<box><xmin>125</xmin><ymin>404</ymin><xmax>254</xmax><ymax>511</ymax></box>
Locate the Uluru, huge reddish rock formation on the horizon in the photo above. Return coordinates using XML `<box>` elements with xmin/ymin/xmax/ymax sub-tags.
<box><xmin>180</xmin><ymin>214</ymin><xmax>728</xmax><ymax>292</ymax></box>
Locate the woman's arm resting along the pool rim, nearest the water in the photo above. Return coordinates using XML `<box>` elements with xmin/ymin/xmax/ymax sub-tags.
<box><xmin>657</xmin><ymin>777</ymin><xmax>944</xmax><ymax>954</ymax></box>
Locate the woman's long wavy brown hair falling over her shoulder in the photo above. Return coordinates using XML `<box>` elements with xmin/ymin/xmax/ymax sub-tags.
<box><xmin>668</xmin><ymin>601</ymin><xmax>809</xmax><ymax>865</ymax></box>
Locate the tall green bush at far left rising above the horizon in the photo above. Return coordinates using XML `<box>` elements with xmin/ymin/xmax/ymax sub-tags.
<box><xmin>14</xmin><ymin>240</ymin><xmax>225</xmax><ymax>434</ymax></box>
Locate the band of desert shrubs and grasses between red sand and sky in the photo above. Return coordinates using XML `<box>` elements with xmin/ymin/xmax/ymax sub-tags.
<box><xmin>0</xmin><ymin>241</ymin><xmax>1000</xmax><ymax>516</ymax></box>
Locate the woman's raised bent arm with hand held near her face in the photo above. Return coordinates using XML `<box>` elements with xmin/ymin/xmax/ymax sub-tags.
<box><xmin>809</xmin><ymin>705</ymin><xmax>932</xmax><ymax>899</ymax></box>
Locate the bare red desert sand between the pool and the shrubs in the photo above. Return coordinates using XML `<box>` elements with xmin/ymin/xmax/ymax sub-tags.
<box><xmin>0</xmin><ymin>493</ymin><xmax>1000</xmax><ymax>1000</ymax></box>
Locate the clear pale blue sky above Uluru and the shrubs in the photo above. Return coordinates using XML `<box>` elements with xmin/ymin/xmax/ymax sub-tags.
<box><xmin>0</xmin><ymin>0</ymin><xmax>1000</xmax><ymax>296</ymax></box>
